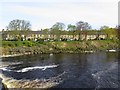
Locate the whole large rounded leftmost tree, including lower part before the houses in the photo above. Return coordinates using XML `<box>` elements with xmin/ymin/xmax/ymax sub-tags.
<box><xmin>7</xmin><ymin>19</ymin><xmax>31</xmax><ymax>40</ymax></box>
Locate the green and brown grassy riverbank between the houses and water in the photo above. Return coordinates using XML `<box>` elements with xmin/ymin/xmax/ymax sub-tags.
<box><xmin>0</xmin><ymin>40</ymin><xmax>119</xmax><ymax>55</ymax></box>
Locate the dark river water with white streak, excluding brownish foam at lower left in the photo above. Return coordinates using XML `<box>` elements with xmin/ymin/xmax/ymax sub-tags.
<box><xmin>0</xmin><ymin>52</ymin><xmax>118</xmax><ymax>89</ymax></box>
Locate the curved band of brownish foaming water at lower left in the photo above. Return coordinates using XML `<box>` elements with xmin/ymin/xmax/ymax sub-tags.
<box><xmin>0</xmin><ymin>72</ymin><xmax>65</xmax><ymax>89</ymax></box>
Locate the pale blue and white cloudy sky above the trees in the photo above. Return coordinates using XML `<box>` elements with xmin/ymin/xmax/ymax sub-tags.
<box><xmin>0</xmin><ymin>0</ymin><xmax>119</xmax><ymax>30</ymax></box>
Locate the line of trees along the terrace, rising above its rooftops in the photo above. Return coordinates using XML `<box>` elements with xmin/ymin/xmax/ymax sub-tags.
<box><xmin>2</xmin><ymin>19</ymin><xmax>118</xmax><ymax>40</ymax></box>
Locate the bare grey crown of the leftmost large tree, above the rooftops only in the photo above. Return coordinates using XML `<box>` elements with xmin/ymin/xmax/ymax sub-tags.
<box><xmin>7</xmin><ymin>19</ymin><xmax>31</xmax><ymax>31</ymax></box>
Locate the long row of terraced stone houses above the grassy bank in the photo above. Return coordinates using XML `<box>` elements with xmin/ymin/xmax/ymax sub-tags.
<box><xmin>2</xmin><ymin>31</ymin><xmax>112</xmax><ymax>41</ymax></box>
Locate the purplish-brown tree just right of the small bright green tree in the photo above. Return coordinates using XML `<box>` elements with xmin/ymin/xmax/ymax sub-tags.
<box><xmin>76</xmin><ymin>21</ymin><xmax>91</xmax><ymax>40</ymax></box>
